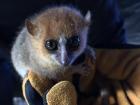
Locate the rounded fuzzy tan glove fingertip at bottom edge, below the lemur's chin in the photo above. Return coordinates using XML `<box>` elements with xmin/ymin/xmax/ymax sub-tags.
<box><xmin>46</xmin><ymin>81</ymin><xmax>77</xmax><ymax>105</ymax></box>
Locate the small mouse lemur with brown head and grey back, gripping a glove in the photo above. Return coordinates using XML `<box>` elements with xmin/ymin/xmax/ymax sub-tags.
<box><xmin>11</xmin><ymin>6</ymin><xmax>95</xmax><ymax>79</ymax></box>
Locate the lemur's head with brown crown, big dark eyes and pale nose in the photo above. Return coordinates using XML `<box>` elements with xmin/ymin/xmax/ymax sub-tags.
<box><xmin>26</xmin><ymin>6</ymin><xmax>90</xmax><ymax>66</ymax></box>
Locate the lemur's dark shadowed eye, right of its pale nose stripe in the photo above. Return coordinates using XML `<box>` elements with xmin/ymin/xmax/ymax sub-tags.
<box><xmin>67</xmin><ymin>36</ymin><xmax>80</xmax><ymax>51</ymax></box>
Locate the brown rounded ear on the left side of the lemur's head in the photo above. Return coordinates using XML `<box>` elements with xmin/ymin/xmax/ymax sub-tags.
<box><xmin>25</xmin><ymin>19</ymin><xmax>38</xmax><ymax>36</ymax></box>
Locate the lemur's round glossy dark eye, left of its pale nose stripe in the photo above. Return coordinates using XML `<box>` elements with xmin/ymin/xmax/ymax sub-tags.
<box><xmin>45</xmin><ymin>39</ymin><xmax>58</xmax><ymax>51</ymax></box>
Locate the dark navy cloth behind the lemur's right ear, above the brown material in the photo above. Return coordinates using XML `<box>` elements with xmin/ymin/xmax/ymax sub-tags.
<box><xmin>75</xmin><ymin>0</ymin><xmax>126</xmax><ymax>47</ymax></box>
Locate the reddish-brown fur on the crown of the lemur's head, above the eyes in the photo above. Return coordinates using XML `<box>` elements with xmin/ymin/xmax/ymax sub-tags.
<box><xmin>35</xmin><ymin>7</ymin><xmax>87</xmax><ymax>39</ymax></box>
